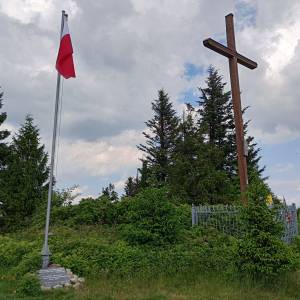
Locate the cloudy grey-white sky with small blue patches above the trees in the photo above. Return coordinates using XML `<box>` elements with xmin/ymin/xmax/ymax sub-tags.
<box><xmin>0</xmin><ymin>0</ymin><xmax>300</xmax><ymax>205</ymax></box>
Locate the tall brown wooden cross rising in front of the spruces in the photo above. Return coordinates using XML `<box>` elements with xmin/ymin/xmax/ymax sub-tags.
<box><xmin>203</xmin><ymin>14</ymin><xmax>257</xmax><ymax>204</ymax></box>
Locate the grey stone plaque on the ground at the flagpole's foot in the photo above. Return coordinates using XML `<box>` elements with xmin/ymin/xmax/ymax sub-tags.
<box><xmin>38</xmin><ymin>267</ymin><xmax>71</xmax><ymax>288</ymax></box>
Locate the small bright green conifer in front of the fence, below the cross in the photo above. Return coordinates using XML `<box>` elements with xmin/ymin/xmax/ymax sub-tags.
<box><xmin>236</xmin><ymin>179</ymin><xmax>296</xmax><ymax>280</ymax></box>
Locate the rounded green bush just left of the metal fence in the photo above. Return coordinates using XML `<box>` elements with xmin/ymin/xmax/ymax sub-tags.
<box><xmin>118</xmin><ymin>188</ymin><xmax>185</xmax><ymax>245</ymax></box>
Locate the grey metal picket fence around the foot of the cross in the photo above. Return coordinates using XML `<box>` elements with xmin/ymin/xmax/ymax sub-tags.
<box><xmin>192</xmin><ymin>204</ymin><xmax>298</xmax><ymax>244</ymax></box>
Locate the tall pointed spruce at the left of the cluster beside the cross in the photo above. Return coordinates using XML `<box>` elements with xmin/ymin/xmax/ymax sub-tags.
<box><xmin>138</xmin><ymin>90</ymin><xmax>179</xmax><ymax>185</ymax></box>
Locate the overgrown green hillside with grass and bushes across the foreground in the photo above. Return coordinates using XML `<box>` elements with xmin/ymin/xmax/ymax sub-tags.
<box><xmin>0</xmin><ymin>189</ymin><xmax>300</xmax><ymax>300</ymax></box>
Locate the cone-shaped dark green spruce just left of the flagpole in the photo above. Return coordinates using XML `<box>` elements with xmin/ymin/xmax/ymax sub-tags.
<box><xmin>0</xmin><ymin>116</ymin><xmax>49</xmax><ymax>227</ymax></box>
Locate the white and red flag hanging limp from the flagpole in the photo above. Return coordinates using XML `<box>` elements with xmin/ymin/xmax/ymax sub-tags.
<box><xmin>56</xmin><ymin>16</ymin><xmax>76</xmax><ymax>79</ymax></box>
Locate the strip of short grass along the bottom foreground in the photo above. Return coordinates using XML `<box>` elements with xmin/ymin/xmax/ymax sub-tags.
<box><xmin>0</xmin><ymin>274</ymin><xmax>300</xmax><ymax>300</ymax></box>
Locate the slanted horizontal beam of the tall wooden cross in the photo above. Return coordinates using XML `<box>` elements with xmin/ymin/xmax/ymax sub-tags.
<box><xmin>203</xmin><ymin>39</ymin><xmax>257</xmax><ymax>70</ymax></box>
